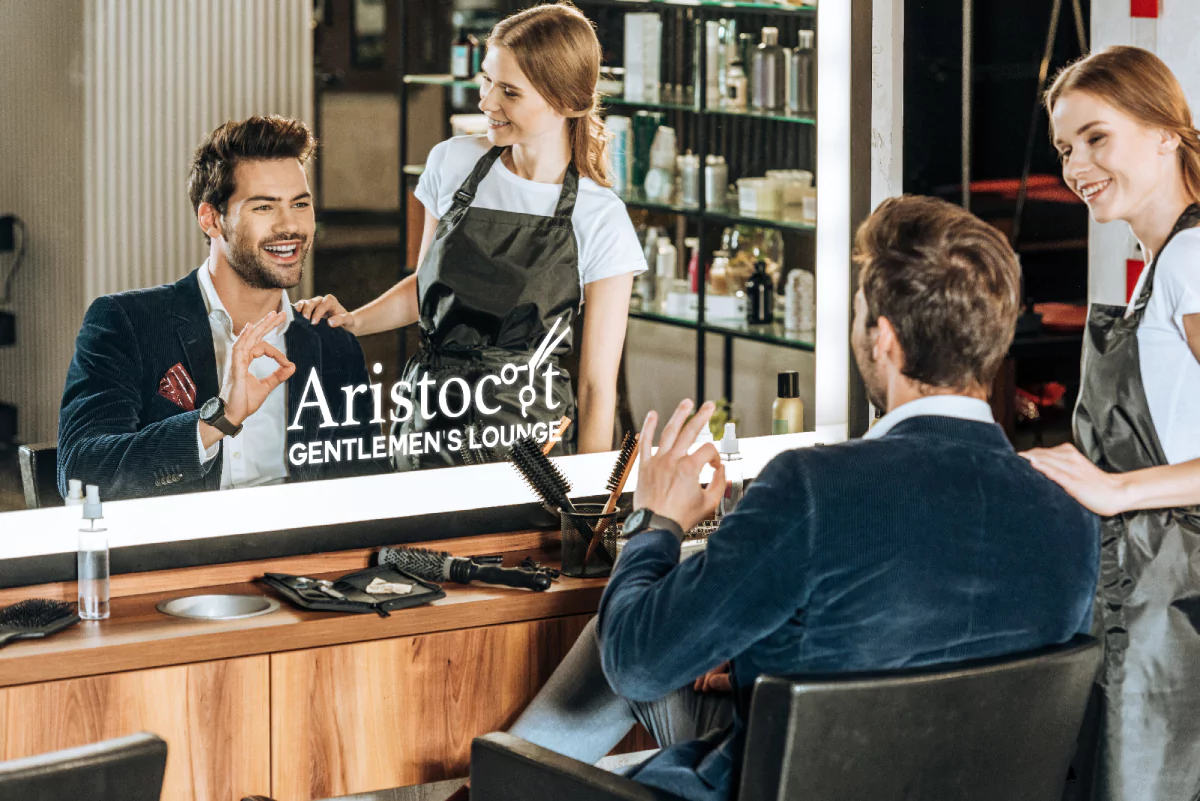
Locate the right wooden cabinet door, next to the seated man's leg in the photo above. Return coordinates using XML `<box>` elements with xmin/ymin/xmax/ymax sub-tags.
<box><xmin>271</xmin><ymin>615</ymin><xmax>590</xmax><ymax>801</ymax></box>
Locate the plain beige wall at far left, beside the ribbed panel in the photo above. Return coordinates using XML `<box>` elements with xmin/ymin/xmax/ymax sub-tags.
<box><xmin>0</xmin><ymin>0</ymin><xmax>85</xmax><ymax>440</ymax></box>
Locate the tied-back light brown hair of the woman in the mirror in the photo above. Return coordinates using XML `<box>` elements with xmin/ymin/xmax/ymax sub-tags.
<box><xmin>487</xmin><ymin>2</ymin><xmax>612</xmax><ymax>186</ymax></box>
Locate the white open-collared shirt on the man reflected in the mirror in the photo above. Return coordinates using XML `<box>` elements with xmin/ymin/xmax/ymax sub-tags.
<box><xmin>196</xmin><ymin>261</ymin><xmax>294</xmax><ymax>489</ymax></box>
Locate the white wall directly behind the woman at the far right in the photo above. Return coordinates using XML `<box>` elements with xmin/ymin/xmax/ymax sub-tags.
<box><xmin>1087</xmin><ymin>0</ymin><xmax>1200</xmax><ymax>303</ymax></box>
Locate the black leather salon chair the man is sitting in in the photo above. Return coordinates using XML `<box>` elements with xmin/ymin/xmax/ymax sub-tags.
<box><xmin>470</xmin><ymin>637</ymin><xmax>1102</xmax><ymax>801</ymax></box>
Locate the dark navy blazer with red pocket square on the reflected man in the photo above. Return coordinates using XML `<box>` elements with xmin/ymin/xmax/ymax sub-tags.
<box><xmin>59</xmin><ymin>270</ymin><xmax>384</xmax><ymax>500</ymax></box>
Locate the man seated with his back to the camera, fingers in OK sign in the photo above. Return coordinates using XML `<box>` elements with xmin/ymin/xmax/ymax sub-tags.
<box><xmin>482</xmin><ymin>197</ymin><xmax>1099</xmax><ymax>801</ymax></box>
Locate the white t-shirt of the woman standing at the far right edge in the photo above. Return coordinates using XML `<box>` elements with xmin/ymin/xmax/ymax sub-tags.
<box><xmin>1130</xmin><ymin>228</ymin><xmax>1200</xmax><ymax>464</ymax></box>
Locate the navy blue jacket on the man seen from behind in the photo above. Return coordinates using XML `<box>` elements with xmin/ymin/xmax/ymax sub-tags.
<box><xmin>599</xmin><ymin>416</ymin><xmax>1099</xmax><ymax>801</ymax></box>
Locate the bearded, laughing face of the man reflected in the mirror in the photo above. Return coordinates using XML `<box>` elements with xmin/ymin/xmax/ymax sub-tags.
<box><xmin>221</xmin><ymin>158</ymin><xmax>317</xmax><ymax>289</ymax></box>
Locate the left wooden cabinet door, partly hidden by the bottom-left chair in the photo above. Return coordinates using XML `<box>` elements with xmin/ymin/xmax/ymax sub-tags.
<box><xmin>0</xmin><ymin>656</ymin><xmax>271</xmax><ymax>801</ymax></box>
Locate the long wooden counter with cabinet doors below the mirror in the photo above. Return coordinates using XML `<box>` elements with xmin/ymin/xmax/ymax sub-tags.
<box><xmin>0</xmin><ymin>532</ymin><xmax>646</xmax><ymax>801</ymax></box>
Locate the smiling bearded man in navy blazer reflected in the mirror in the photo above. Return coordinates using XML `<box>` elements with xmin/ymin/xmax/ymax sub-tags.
<box><xmin>58</xmin><ymin>116</ymin><xmax>380</xmax><ymax>500</ymax></box>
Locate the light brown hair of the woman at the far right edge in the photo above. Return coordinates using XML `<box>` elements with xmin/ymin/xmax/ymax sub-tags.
<box><xmin>1044</xmin><ymin>46</ymin><xmax>1200</xmax><ymax>200</ymax></box>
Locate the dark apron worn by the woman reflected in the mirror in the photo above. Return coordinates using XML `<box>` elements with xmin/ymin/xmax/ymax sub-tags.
<box><xmin>391</xmin><ymin>147</ymin><xmax>582</xmax><ymax>470</ymax></box>
